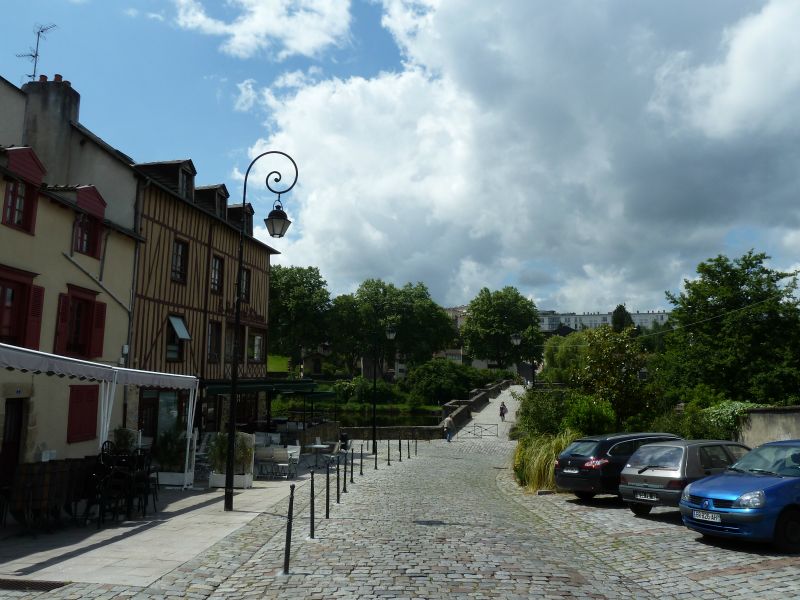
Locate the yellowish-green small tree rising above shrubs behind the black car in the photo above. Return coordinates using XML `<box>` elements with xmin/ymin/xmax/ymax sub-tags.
<box><xmin>581</xmin><ymin>325</ymin><xmax>644</xmax><ymax>429</ymax></box>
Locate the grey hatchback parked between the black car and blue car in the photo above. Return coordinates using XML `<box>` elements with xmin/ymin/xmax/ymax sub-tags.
<box><xmin>619</xmin><ymin>440</ymin><xmax>750</xmax><ymax>516</ymax></box>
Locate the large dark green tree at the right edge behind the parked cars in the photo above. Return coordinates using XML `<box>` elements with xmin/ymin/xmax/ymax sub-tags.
<box><xmin>661</xmin><ymin>250</ymin><xmax>800</xmax><ymax>403</ymax></box>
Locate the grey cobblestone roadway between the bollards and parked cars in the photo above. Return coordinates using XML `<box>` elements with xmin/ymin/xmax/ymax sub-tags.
<box><xmin>6</xmin><ymin>392</ymin><xmax>800</xmax><ymax>600</ymax></box>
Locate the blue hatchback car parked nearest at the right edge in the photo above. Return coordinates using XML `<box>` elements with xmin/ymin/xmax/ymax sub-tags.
<box><xmin>680</xmin><ymin>440</ymin><xmax>800</xmax><ymax>552</ymax></box>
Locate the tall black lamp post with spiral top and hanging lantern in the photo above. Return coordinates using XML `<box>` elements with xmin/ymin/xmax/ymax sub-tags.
<box><xmin>225</xmin><ymin>150</ymin><xmax>298</xmax><ymax>511</ymax></box>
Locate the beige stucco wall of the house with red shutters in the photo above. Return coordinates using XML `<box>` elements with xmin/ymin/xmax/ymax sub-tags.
<box><xmin>0</xmin><ymin>180</ymin><xmax>135</xmax><ymax>461</ymax></box>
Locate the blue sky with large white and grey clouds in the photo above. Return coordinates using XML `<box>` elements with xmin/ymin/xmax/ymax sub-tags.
<box><xmin>0</xmin><ymin>0</ymin><xmax>800</xmax><ymax>312</ymax></box>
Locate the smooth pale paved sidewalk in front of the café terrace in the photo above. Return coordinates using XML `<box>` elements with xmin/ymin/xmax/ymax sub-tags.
<box><xmin>0</xmin><ymin>473</ymin><xmax>308</xmax><ymax>587</ymax></box>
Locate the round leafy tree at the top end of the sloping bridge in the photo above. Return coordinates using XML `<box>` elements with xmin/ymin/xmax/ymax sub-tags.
<box><xmin>461</xmin><ymin>286</ymin><xmax>543</xmax><ymax>367</ymax></box>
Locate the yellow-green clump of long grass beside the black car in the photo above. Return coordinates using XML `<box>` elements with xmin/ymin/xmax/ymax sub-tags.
<box><xmin>514</xmin><ymin>429</ymin><xmax>580</xmax><ymax>491</ymax></box>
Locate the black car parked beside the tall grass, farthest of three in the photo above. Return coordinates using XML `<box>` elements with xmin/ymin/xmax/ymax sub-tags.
<box><xmin>555</xmin><ymin>433</ymin><xmax>681</xmax><ymax>500</ymax></box>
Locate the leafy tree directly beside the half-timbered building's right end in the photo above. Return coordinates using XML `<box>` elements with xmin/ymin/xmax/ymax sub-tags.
<box><xmin>269</xmin><ymin>265</ymin><xmax>330</xmax><ymax>364</ymax></box>
